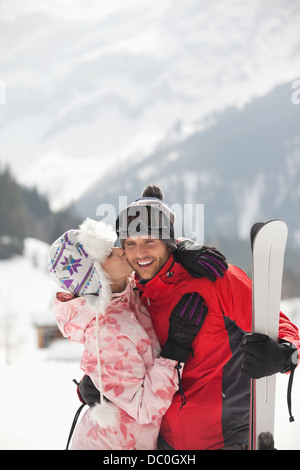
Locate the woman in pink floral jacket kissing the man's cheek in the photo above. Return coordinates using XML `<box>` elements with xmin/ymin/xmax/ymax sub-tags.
<box><xmin>49</xmin><ymin>219</ymin><xmax>204</xmax><ymax>450</ymax></box>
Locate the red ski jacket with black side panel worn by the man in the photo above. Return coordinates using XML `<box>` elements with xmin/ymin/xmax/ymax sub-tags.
<box><xmin>136</xmin><ymin>255</ymin><xmax>299</xmax><ymax>450</ymax></box>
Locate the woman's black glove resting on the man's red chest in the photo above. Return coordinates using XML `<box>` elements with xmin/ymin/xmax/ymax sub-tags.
<box><xmin>160</xmin><ymin>292</ymin><xmax>208</xmax><ymax>362</ymax></box>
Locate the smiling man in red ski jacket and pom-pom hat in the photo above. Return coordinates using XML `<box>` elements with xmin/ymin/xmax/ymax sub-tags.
<box><xmin>116</xmin><ymin>186</ymin><xmax>299</xmax><ymax>450</ymax></box>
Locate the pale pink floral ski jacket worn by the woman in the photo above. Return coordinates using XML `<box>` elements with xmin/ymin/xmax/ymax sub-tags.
<box><xmin>53</xmin><ymin>281</ymin><xmax>182</xmax><ymax>450</ymax></box>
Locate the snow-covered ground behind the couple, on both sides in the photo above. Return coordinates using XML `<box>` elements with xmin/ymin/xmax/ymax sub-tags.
<box><xmin>0</xmin><ymin>240</ymin><xmax>300</xmax><ymax>450</ymax></box>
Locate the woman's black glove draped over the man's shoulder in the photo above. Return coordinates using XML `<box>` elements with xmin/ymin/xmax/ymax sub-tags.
<box><xmin>174</xmin><ymin>240</ymin><xmax>228</xmax><ymax>281</ymax></box>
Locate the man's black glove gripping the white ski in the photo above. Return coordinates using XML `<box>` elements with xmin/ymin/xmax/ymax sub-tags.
<box><xmin>242</xmin><ymin>333</ymin><xmax>296</xmax><ymax>379</ymax></box>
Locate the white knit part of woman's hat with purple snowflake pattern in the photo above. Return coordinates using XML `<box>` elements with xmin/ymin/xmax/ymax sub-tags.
<box><xmin>48</xmin><ymin>230</ymin><xmax>101</xmax><ymax>302</ymax></box>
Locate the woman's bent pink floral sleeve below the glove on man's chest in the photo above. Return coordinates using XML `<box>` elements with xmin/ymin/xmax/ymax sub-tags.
<box><xmin>89</xmin><ymin>328</ymin><xmax>182</xmax><ymax>424</ymax></box>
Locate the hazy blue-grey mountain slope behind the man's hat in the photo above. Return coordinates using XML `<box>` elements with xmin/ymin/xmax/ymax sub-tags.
<box><xmin>75</xmin><ymin>84</ymin><xmax>300</xmax><ymax>250</ymax></box>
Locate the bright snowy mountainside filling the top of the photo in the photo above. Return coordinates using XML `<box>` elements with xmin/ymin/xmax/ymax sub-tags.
<box><xmin>0</xmin><ymin>0</ymin><xmax>300</xmax><ymax>209</ymax></box>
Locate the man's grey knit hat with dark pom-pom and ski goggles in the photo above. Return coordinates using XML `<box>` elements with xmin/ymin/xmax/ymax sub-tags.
<box><xmin>116</xmin><ymin>184</ymin><xmax>176</xmax><ymax>251</ymax></box>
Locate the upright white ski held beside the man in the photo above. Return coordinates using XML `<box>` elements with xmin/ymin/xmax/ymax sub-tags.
<box><xmin>249</xmin><ymin>220</ymin><xmax>287</xmax><ymax>450</ymax></box>
